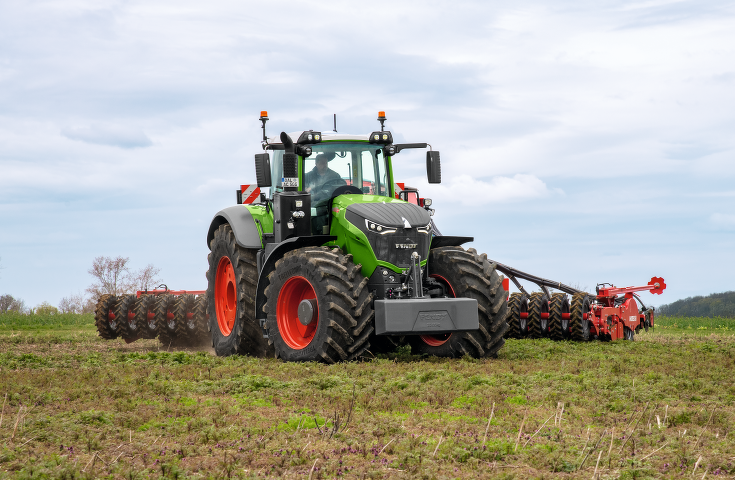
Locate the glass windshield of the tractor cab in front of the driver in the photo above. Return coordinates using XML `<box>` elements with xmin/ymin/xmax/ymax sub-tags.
<box><xmin>301</xmin><ymin>142</ymin><xmax>389</xmax><ymax>206</ymax></box>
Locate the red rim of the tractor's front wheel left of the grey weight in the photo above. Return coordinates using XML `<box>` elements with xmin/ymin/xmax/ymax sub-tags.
<box><xmin>276</xmin><ymin>277</ymin><xmax>319</xmax><ymax>350</ymax></box>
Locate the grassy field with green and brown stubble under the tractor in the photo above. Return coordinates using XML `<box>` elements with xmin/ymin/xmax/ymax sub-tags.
<box><xmin>0</xmin><ymin>314</ymin><xmax>735</xmax><ymax>479</ymax></box>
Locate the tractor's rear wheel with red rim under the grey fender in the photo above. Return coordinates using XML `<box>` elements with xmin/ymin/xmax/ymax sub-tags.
<box><xmin>207</xmin><ymin>224</ymin><xmax>274</xmax><ymax>357</ymax></box>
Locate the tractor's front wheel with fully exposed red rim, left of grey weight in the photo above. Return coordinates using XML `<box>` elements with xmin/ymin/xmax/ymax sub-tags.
<box><xmin>264</xmin><ymin>247</ymin><xmax>374</xmax><ymax>363</ymax></box>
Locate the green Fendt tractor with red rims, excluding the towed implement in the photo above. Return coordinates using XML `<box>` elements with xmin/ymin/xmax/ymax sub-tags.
<box><xmin>206</xmin><ymin>112</ymin><xmax>508</xmax><ymax>363</ymax></box>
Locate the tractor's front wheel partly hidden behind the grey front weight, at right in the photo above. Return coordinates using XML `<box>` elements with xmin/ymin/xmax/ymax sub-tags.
<box><xmin>407</xmin><ymin>247</ymin><xmax>508</xmax><ymax>358</ymax></box>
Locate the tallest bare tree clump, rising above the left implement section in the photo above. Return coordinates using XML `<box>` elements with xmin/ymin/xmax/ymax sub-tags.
<box><xmin>86</xmin><ymin>257</ymin><xmax>162</xmax><ymax>304</ymax></box>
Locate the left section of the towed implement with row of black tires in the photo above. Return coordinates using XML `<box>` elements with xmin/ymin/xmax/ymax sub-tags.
<box><xmin>95</xmin><ymin>285</ymin><xmax>208</xmax><ymax>347</ymax></box>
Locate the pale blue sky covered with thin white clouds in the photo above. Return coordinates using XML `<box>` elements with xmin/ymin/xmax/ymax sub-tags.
<box><xmin>0</xmin><ymin>0</ymin><xmax>735</xmax><ymax>306</ymax></box>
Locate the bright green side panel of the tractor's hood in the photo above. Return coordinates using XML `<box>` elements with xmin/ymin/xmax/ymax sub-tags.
<box><xmin>329</xmin><ymin>194</ymin><xmax>431</xmax><ymax>277</ymax></box>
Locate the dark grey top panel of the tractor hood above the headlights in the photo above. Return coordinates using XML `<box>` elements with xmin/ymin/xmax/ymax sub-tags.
<box><xmin>345</xmin><ymin>202</ymin><xmax>431</xmax><ymax>233</ymax></box>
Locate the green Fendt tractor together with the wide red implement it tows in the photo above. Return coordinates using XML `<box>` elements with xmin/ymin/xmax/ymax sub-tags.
<box><xmin>95</xmin><ymin>112</ymin><xmax>666</xmax><ymax>363</ymax></box>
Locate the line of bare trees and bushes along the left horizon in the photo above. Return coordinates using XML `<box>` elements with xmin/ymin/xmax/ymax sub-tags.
<box><xmin>0</xmin><ymin>256</ymin><xmax>162</xmax><ymax>314</ymax></box>
